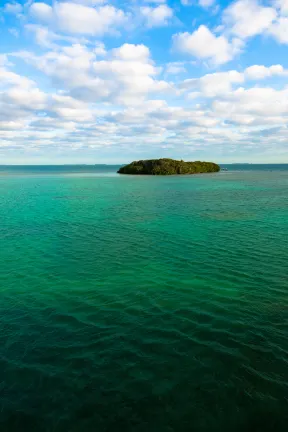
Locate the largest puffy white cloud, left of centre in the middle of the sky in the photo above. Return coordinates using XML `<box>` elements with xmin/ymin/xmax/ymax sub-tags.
<box><xmin>15</xmin><ymin>44</ymin><xmax>172</xmax><ymax>104</ymax></box>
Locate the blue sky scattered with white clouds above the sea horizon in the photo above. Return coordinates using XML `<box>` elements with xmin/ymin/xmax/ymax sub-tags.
<box><xmin>0</xmin><ymin>0</ymin><xmax>288</xmax><ymax>164</ymax></box>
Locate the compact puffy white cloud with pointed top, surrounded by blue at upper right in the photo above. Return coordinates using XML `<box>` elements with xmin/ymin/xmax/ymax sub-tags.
<box><xmin>173</xmin><ymin>25</ymin><xmax>242</xmax><ymax>65</ymax></box>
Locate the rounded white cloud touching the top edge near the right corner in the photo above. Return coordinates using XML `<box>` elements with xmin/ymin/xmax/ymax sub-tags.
<box><xmin>223</xmin><ymin>0</ymin><xmax>277</xmax><ymax>39</ymax></box>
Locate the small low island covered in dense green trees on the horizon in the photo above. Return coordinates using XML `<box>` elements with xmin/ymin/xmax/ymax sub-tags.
<box><xmin>118</xmin><ymin>158</ymin><xmax>220</xmax><ymax>175</ymax></box>
